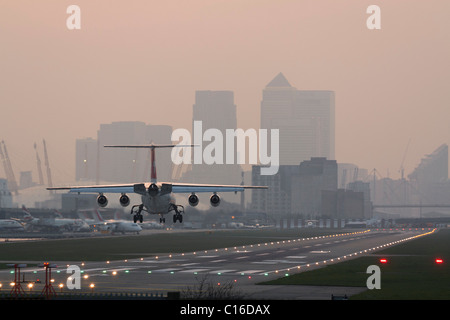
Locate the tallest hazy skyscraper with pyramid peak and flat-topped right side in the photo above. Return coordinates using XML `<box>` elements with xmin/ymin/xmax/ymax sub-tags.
<box><xmin>261</xmin><ymin>73</ymin><xmax>335</xmax><ymax>165</ymax></box>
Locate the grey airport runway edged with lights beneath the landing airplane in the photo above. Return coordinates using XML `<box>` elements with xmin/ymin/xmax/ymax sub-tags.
<box><xmin>0</xmin><ymin>229</ymin><xmax>436</xmax><ymax>299</ymax></box>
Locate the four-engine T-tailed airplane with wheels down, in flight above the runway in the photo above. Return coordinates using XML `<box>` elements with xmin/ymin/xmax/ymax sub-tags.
<box><xmin>47</xmin><ymin>143</ymin><xmax>267</xmax><ymax>223</ymax></box>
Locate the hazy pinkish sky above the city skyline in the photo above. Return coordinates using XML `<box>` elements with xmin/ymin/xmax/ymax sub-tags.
<box><xmin>0</xmin><ymin>0</ymin><xmax>450</xmax><ymax>184</ymax></box>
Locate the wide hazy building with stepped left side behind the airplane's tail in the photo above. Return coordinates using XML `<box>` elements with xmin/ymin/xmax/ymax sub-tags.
<box><xmin>76</xmin><ymin>121</ymin><xmax>173</xmax><ymax>183</ymax></box>
